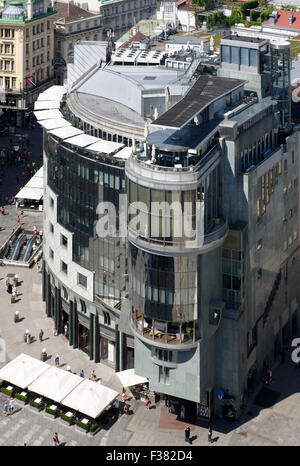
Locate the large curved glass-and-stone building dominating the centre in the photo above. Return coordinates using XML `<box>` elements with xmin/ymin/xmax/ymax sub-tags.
<box><xmin>36</xmin><ymin>36</ymin><xmax>300</xmax><ymax>419</ymax></box>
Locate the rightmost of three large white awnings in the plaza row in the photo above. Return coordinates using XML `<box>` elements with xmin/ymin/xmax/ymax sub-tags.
<box><xmin>62</xmin><ymin>379</ymin><xmax>119</xmax><ymax>419</ymax></box>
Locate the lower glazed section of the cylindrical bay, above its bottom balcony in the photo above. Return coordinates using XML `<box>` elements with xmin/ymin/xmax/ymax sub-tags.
<box><xmin>129</xmin><ymin>243</ymin><xmax>199</xmax><ymax>343</ymax></box>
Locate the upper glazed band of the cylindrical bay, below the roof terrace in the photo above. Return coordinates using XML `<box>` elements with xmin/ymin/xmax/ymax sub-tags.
<box><xmin>127</xmin><ymin>165</ymin><xmax>222</xmax><ymax>245</ymax></box>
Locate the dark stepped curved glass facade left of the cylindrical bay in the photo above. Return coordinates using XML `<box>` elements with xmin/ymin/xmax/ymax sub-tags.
<box><xmin>44</xmin><ymin>133</ymin><xmax>127</xmax><ymax>306</ymax></box>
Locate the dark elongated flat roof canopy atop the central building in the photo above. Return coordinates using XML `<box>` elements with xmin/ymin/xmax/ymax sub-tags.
<box><xmin>153</xmin><ymin>75</ymin><xmax>245</xmax><ymax>129</ymax></box>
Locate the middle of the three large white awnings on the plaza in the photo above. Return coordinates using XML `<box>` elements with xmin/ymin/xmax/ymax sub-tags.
<box><xmin>28</xmin><ymin>367</ymin><xmax>84</xmax><ymax>403</ymax></box>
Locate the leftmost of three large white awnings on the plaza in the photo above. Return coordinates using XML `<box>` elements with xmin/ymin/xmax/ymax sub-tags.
<box><xmin>0</xmin><ymin>353</ymin><xmax>50</xmax><ymax>389</ymax></box>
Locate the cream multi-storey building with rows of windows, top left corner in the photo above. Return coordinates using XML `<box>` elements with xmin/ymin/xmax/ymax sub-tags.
<box><xmin>0</xmin><ymin>0</ymin><xmax>54</xmax><ymax>126</ymax></box>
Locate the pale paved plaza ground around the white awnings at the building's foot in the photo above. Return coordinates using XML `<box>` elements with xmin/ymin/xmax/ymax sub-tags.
<box><xmin>0</xmin><ymin>266</ymin><xmax>300</xmax><ymax>447</ymax></box>
